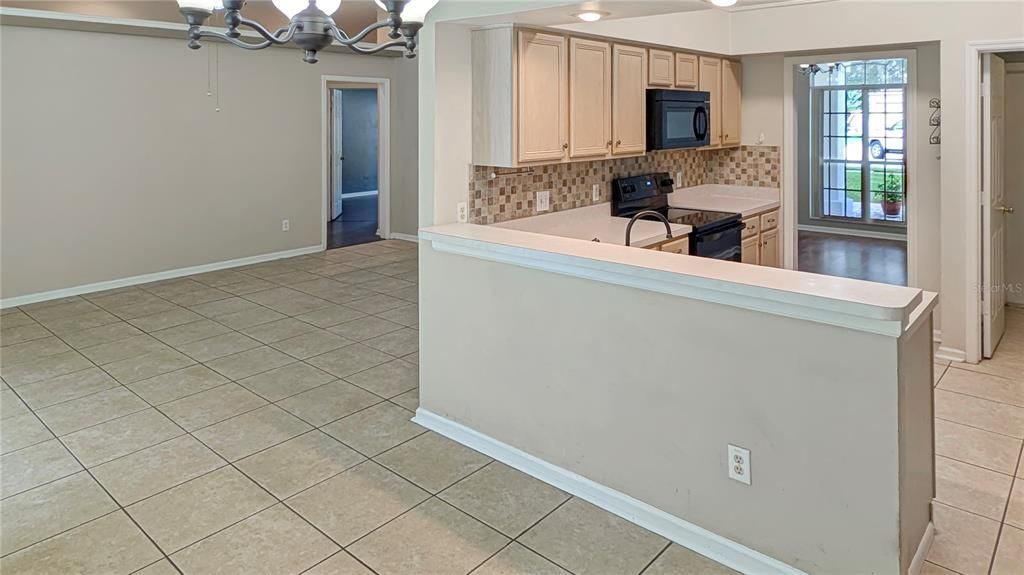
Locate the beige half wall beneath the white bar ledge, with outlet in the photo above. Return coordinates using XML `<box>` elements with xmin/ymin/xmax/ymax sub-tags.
<box><xmin>420</xmin><ymin>241</ymin><xmax>933</xmax><ymax>574</ymax></box>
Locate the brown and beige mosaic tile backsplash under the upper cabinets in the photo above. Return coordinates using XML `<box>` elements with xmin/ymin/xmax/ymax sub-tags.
<box><xmin>469</xmin><ymin>146</ymin><xmax>780</xmax><ymax>224</ymax></box>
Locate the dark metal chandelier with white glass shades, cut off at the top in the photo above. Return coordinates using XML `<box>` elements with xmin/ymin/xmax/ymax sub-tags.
<box><xmin>178</xmin><ymin>0</ymin><xmax>437</xmax><ymax>63</ymax></box>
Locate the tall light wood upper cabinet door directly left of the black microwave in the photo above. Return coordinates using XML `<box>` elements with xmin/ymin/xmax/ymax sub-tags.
<box><xmin>611</xmin><ymin>44</ymin><xmax>647</xmax><ymax>156</ymax></box>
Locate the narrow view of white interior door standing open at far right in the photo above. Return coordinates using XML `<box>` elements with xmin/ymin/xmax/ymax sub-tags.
<box><xmin>981</xmin><ymin>54</ymin><xmax>1007</xmax><ymax>357</ymax></box>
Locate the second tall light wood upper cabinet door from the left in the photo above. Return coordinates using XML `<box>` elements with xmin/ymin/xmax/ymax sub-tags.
<box><xmin>569</xmin><ymin>38</ymin><xmax>612</xmax><ymax>158</ymax></box>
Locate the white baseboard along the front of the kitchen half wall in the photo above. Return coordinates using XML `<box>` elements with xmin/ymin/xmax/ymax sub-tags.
<box><xmin>413</xmin><ymin>407</ymin><xmax>806</xmax><ymax>575</ymax></box>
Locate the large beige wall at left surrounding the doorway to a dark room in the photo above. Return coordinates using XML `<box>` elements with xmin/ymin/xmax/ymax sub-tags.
<box><xmin>0</xmin><ymin>26</ymin><xmax>417</xmax><ymax>298</ymax></box>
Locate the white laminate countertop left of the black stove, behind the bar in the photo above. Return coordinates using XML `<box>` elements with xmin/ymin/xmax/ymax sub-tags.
<box><xmin>490</xmin><ymin>202</ymin><xmax>693</xmax><ymax>248</ymax></box>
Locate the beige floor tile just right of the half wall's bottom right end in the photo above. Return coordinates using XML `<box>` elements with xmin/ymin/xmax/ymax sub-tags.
<box><xmin>928</xmin><ymin>503</ymin><xmax>999</xmax><ymax>575</ymax></box>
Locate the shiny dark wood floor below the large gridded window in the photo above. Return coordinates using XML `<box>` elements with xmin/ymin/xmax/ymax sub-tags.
<box><xmin>798</xmin><ymin>231</ymin><xmax>906</xmax><ymax>285</ymax></box>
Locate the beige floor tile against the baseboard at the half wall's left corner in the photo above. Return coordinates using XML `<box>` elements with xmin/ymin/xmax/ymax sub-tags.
<box><xmin>376</xmin><ymin>432</ymin><xmax>492</xmax><ymax>493</ymax></box>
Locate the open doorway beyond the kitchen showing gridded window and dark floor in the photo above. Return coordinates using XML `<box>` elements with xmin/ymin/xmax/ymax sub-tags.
<box><xmin>794</xmin><ymin>54</ymin><xmax>913</xmax><ymax>285</ymax></box>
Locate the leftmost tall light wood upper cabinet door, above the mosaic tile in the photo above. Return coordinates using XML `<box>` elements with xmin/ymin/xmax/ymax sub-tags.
<box><xmin>516</xmin><ymin>31</ymin><xmax>569</xmax><ymax>163</ymax></box>
